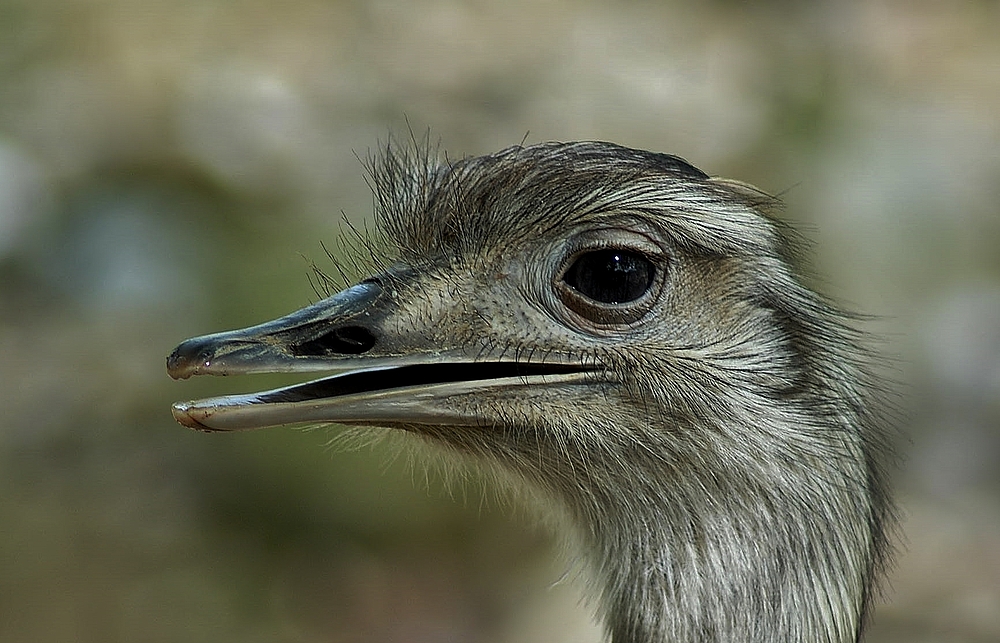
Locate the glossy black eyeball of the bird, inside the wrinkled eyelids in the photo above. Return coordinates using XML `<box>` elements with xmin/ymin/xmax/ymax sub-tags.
<box><xmin>563</xmin><ymin>250</ymin><xmax>655</xmax><ymax>304</ymax></box>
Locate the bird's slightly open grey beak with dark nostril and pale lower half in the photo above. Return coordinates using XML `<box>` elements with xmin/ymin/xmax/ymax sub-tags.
<box><xmin>167</xmin><ymin>280</ymin><xmax>597</xmax><ymax>431</ymax></box>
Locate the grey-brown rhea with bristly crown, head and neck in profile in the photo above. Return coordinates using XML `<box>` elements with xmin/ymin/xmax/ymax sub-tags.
<box><xmin>167</xmin><ymin>142</ymin><xmax>892</xmax><ymax>643</ymax></box>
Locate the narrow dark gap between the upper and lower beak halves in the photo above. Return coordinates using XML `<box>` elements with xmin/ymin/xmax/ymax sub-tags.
<box><xmin>257</xmin><ymin>362</ymin><xmax>596</xmax><ymax>404</ymax></box>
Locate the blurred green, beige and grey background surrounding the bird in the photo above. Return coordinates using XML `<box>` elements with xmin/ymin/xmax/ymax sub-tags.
<box><xmin>0</xmin><ymin>0</ymin><xmax>1000</xmax><ymax>643</ymax></box>
